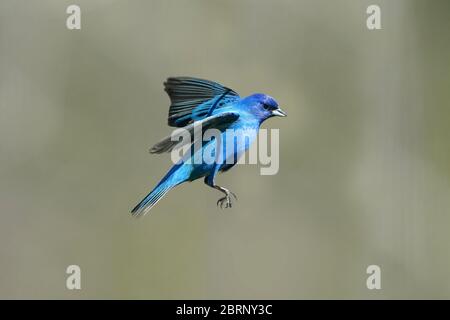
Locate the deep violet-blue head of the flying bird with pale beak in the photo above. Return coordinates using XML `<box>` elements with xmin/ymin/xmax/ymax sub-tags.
<box><xmin>243</xmin><ymin>93</ymin><xmax>287</xmax><ymax>122</ymax></box>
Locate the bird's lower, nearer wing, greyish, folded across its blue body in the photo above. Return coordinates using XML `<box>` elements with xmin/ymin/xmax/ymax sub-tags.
<box><xmin>150</xmin><ymin>112</ymin><xmax>239</xmax><ymax>153</ymax></box>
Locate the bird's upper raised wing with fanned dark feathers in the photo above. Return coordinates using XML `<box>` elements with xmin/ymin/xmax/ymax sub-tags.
<box><xmin>164</xmin><ymin>77</ymin><xmax>239</xmax><ymax>127</ymax></box>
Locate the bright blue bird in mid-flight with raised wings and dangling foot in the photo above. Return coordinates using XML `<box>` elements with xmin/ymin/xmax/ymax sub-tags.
<box><xmin>131</xmin><ymin>77</ymin><xmax>286</xmax><ymax>216</ymax></box>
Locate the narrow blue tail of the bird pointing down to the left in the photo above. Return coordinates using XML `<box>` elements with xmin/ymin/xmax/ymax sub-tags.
<box><xmin>131</xmin><ymin>166</ymin><xmax>183</xmax><ymax>217</ymax></box>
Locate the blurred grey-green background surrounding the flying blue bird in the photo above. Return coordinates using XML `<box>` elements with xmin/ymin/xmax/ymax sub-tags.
<box><xmin>0</xmin><ymin>0</ymin><xmax>450</xmax><ymax>299</ymax></box>
